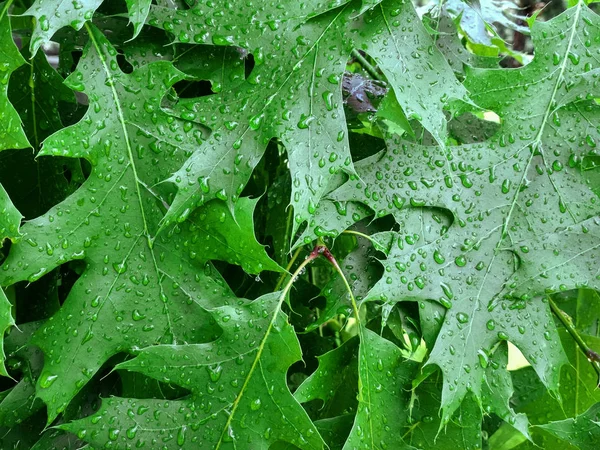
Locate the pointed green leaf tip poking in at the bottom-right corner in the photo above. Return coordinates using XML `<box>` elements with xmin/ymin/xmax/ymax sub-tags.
<box><xmin>538</xmin><ymin>403</ymin><xmax>600</xmax><ymax>450</ymax></box>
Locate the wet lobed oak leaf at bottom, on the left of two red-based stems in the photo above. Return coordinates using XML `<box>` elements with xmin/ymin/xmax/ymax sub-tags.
<box><xmin>60</xmin><ymin>292</ymin><xmax>324</xmax><ymax>450</ymax></box>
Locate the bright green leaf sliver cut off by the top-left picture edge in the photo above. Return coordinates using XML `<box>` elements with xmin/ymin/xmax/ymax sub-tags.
<box><xmin>0</xmin><ymin>2</ymin><xmax>30</xmax><ymax>152</ymax></box>
